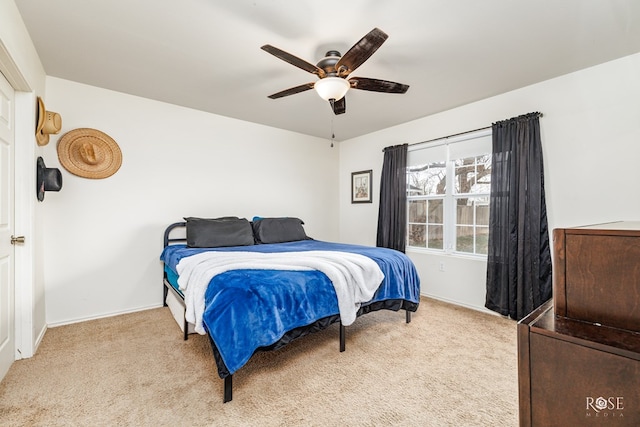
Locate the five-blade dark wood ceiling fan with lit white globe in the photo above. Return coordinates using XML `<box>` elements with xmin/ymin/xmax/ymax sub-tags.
<box><xmin>261</xmin><ymin>28</ymin><xmax>409</xmax><ymax>114</ymax></box>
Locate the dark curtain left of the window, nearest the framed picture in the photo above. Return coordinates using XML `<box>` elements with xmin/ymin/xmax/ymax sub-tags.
<box><xmin>376</xmin><ymin>144</ymin><xmax>409</xmax><ymax>252</ymax></box>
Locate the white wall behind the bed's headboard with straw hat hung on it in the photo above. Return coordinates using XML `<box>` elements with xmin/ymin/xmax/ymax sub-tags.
<box><xmin>43</xmin><ymin>77</ymin><xmax>339</xmax><ymax>325</ymax></box>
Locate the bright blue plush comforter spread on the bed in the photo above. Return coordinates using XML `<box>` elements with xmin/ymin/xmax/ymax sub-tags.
<box><xmin>160</xmin><ymin>240</ymin><xmax>420</xmax><ymax>374</ymax></box>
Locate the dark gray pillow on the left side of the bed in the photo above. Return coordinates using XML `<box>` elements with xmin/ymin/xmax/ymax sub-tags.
<box><xmin>185</xmin><ymin>217</ymin><xmax>254</xmax><ymax>248</ymax></box>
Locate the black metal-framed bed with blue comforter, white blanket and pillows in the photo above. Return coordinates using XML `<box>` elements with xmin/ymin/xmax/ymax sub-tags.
<box><xmin>160</xmin><ymin>217</ymin><xmax>420</xmax><ymax>402</ymax></box>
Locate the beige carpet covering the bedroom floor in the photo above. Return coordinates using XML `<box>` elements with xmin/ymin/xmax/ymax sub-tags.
<box><xmin>0</xmin><ymin>298</ymin><xmax>518</xmax><ymax>427</ymax></box>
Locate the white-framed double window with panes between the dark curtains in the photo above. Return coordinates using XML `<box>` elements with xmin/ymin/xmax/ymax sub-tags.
<box><xmin>407</xmin><ymin>130</ymin><xmax>491</xmax><ymax>255</ymax></box>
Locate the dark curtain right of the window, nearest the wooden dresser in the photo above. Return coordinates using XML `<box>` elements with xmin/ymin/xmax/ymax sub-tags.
<box><xmin>485</xmin><ymin>113</ymin><xmax>552</xmax><ymax>320</ymax></box>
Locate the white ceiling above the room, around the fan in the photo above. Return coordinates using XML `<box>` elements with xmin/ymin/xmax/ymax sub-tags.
<box><xmin>15</xmin><ymin>0</ymin><xmax>640</xmax><ymax>140</ymax></box>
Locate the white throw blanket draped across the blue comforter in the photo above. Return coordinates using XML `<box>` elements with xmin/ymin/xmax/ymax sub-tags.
<box><xmin>176</xmin><ymin>251</ymin><xmax>384</xmax><ymax>335</ymax></box>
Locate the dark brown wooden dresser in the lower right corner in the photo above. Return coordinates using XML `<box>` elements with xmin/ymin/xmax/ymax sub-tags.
<box><xmin>518</xmin><ymin>222</ymin><xmax>640</xmax><ymax>427</ymax></box>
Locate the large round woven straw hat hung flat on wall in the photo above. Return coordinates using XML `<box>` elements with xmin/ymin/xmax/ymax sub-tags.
<box><xmin>58</xmin><ymin>128</ymin><xmax>122</xmax><ymax>179</ymax></box>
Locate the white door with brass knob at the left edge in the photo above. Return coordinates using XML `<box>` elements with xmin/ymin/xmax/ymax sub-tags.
<box><xmin>0</xmin><ymin>73</ymin><xmax>15</xmax><ymax>380</ymax></box>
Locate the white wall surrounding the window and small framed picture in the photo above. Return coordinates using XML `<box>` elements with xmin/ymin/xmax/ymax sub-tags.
<box><xmin>340</xmin><ymin>54</ymin><xmax>640</xmax><ymax>310</ymax></box>
